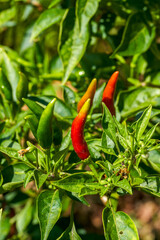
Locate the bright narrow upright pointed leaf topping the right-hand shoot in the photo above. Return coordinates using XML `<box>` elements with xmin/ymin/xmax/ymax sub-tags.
<box><xmin>136</xmin><ymin>106</ymin><xmax>152</xmax><ymax>141</ymax></box>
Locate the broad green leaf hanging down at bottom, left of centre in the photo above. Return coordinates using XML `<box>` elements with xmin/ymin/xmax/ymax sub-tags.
<box><xmin>37</xmin><ymin>190</ymin><xmax>62</xmax><ymax>240</ymax></box>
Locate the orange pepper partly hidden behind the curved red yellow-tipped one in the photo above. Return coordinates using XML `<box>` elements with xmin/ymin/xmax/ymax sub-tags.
<box><xmin>77</xmin><ymin>78</ymin><xmax>97</xmax><ymax>112</ymax></box>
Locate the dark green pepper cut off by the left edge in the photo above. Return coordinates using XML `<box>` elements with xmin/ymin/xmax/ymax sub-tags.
<box><xmin>0</xmin><ymin>68</ymin><xmax>12</xmax><ymax>101</ymax></box>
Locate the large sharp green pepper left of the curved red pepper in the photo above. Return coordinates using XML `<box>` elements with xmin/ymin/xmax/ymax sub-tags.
<box><xmin>37</xmin><ymin>98</ymin><xmax>56</xmax><ymax>149</ymax></box>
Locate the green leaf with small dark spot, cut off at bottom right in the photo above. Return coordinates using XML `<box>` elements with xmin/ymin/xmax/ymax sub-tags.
<box><xmin>103</xmin><ymin>207</ymin><xmax>139</xmax><ymax>240</ymax></box>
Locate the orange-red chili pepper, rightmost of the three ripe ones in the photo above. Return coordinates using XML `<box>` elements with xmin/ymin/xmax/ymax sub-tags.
<box><xmin>102</xmin><ymin>71</ymin><xmax>119</xmax><ymax>116</ymax></box>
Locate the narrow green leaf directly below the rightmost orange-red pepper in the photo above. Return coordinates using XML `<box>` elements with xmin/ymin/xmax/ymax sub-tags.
<box><xmin>102</xmin><ymin>103</ymin><xmax>119</xmax><ymax>149</ymax></box>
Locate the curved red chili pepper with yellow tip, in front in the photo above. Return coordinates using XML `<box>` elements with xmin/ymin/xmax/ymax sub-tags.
<box><xmin>71</xmin><ymin>99</ymin><xmax>91</xmax><ymax>160</ymax></box>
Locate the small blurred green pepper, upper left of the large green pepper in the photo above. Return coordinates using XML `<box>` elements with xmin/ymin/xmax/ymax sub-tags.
<box><xmin>16</xmin><ymin>72</ymin><xmax>28</xmax><ymax>102</ymax></box>
